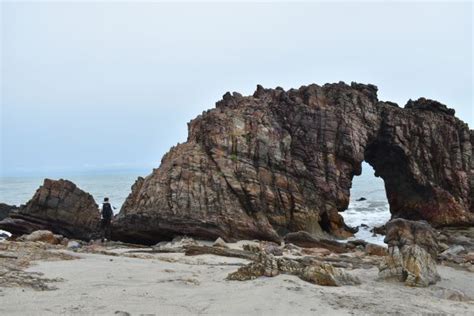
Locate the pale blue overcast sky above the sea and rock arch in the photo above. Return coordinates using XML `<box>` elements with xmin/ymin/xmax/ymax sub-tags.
<box><xmin>1</xmin><ymin>2</ymin><xmax>474</xmax><ymax>176</ymax></box>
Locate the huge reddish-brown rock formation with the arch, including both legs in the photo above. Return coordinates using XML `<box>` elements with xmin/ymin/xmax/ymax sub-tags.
<box><xmin>114</xmin><ymin>83</ymin><xmax>474</xmax><ymax>243</ymax></box>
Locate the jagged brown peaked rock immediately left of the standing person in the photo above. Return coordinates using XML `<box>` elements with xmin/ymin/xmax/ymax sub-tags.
<box><xmin>0</xmin><ymin>179</ymin><xmax>100</xmax><ymax>240</ymax></box>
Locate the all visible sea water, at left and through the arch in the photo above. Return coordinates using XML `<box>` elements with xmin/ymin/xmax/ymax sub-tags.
<box><xmin>0</xmin><ymin>163</ymin><xmax>390</xmax><ymax>245</ymax></box>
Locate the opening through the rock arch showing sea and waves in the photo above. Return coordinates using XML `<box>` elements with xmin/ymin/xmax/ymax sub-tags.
<box><xmin>341</xmin><ymin>162</ymin><xmax>391</xmax><ymax>245</ymax></box>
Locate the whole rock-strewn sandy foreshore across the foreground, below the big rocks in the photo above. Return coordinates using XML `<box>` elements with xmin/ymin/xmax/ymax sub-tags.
<box><xmin>0</xmin><ymin>226</ymin><xmax>474</xmax><ymax>315</ymax></box>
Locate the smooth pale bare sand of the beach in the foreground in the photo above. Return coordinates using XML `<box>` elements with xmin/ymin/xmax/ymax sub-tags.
<box><xmin>0</xmin><ymin>241</ymin><xmax>474</xmax><ymax>315</ymax></box>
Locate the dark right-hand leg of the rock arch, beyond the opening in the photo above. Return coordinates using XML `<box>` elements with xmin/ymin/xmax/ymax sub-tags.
<box><xmin>365</xmin><ymin>98</ymin><xmax>474</xmax><ymax>226</ymax></box>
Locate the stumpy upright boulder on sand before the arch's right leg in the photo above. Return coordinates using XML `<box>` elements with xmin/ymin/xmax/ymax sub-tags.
<box><xmin>379</xmin><ymin>219</ymin><xmax>440</xmax><ymax>287</ymax></box>
